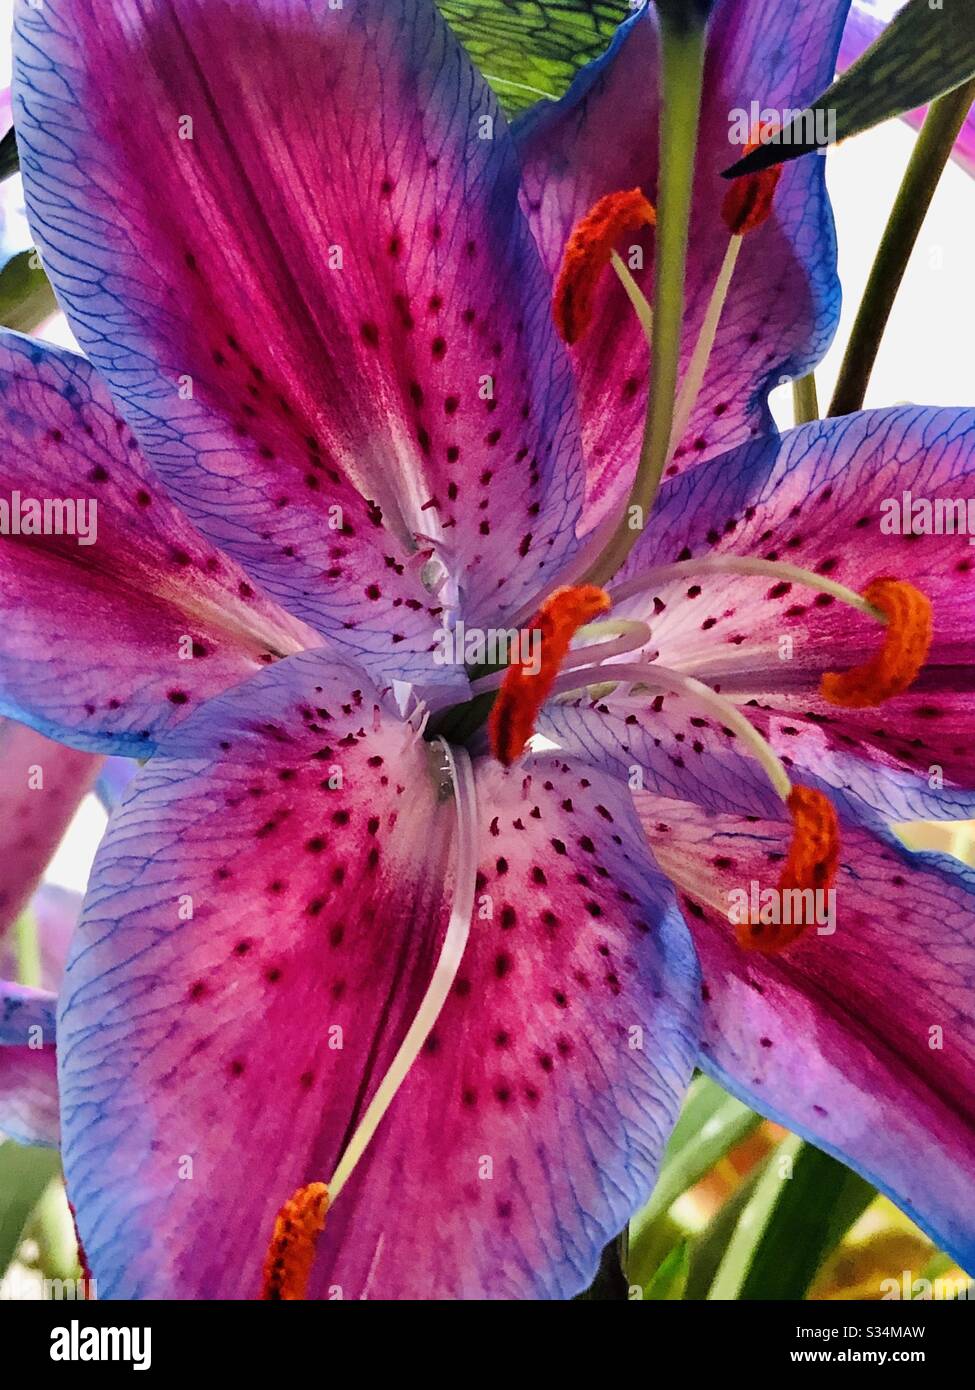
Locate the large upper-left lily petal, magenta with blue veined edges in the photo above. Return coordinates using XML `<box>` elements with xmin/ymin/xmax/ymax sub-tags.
<box><xmin>15</xmin><ymin>0</ymin><xmax>583</xmax><ymax>656</ymax></box>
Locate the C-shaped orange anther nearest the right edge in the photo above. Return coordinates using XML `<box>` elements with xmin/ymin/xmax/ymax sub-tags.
<box><xmin>819</xmin><ymin>580</ymin><xmax>933</xmax><ymax>709</ymax></box>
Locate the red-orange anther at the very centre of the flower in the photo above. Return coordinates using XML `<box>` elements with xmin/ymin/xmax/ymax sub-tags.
<box><xmin>488</xmin><ymin>584</ymin><xmax>609</xmax><ymax>767</ymax></box>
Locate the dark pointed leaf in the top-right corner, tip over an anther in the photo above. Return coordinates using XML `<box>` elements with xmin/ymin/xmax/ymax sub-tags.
<box><xmin>725</xmin><ymin>0</ymin><xmax>975</xmax><ymax>178</ymax></box>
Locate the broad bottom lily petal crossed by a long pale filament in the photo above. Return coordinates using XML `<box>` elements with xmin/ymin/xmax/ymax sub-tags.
<box><xmin>60</xmin><ymin>653</ymin><xmax>698</xmax><ymax>1298</ymax></box>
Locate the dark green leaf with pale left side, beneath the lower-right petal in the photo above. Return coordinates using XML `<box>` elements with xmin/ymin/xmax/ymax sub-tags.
<box><xmin>708</xmin><ymin>1136</ymin><xmax>876</xmax><ymax>1302</ymax></box>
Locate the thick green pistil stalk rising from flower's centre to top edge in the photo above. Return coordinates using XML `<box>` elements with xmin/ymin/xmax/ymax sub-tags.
<box><xmin>587</xmin><ymin>14</ymin><xmax>707</xmax><ymax>584</ymax></box>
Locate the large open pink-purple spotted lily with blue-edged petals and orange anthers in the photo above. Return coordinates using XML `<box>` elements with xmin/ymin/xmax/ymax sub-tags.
<box><xmin>0</xmin><ymin>0</ymin><xmax>975</xmax><ymax>1298</ymax></box>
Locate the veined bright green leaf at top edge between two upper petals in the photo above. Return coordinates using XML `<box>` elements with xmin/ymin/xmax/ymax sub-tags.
<box><xmin>438</xmin><ymin>0</ymin><xmax>620</xmax><ymax>113</ymax></box>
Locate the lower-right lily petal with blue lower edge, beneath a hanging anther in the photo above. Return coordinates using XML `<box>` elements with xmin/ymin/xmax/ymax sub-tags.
<box><xmin>637</xmin><ymin>796</ymin><xmax>975</xmax><ymax>1269</ymax></box>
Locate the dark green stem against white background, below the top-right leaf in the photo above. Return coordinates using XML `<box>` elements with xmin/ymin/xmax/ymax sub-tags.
<box><xmin>829</xmin><ymin>78</ymin><xmax>975</xmax><ymax>416</ymax></box>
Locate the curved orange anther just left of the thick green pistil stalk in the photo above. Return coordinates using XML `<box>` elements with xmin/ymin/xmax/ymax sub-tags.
<box><xmin>552</xmin><ymin>188</ymin><xmax>656</xmax><ymax>345</ymax></box>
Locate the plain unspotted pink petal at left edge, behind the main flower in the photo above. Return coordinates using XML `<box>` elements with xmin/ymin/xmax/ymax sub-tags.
<box><xmin>0</xmin><ymin>720</ymin><xmax>102</xmax><ymax>939</ymax></box>
